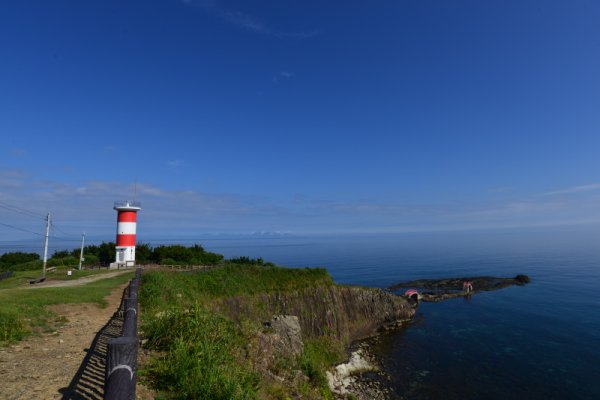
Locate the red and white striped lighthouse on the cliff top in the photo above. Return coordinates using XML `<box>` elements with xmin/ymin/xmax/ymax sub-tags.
<box><xmin>111</xmin><ymin>201</ymin><xmax>142</xmax><ymax>268</ymax></box>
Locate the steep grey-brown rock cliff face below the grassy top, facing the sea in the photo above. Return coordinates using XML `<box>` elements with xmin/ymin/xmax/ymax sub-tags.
<box><xmin>219</xmin><ymin>285</ymin><xmax>415</xmax><ymax>343</ymax></box>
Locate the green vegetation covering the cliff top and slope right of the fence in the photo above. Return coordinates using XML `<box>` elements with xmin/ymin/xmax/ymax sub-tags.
<box><xmin>140</xmin><ymin>262</ymin><xmax>344</xmax><ymax>399</ymax></box>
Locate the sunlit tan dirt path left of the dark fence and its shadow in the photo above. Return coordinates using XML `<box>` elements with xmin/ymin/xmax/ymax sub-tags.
<box><xmin>0</xmin><ymin>282</ymin><xmax>127</xmax><ymax>400</ymax></box>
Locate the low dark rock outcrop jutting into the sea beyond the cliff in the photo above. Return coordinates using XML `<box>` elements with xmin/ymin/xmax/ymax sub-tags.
<box><xmin>388</xmin><ymin>274</ymin><xmax>530</xmax><ymax>302</ymax></box>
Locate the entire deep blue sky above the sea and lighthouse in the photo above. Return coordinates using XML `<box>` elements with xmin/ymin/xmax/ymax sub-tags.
<box><xmin>0</xmin><ymin>0</ymin><xmax>600</xmax><ymax>240</ymax></box>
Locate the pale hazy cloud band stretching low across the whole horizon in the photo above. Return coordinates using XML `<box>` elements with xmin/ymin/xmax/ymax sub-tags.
<box><xmin>0</xmin><ymin>170</ymin><xmax>600</xmax><ymax>240</ymax></box>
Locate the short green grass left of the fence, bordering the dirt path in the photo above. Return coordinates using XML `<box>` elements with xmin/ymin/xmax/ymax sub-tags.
<box><xmin>0</xmin><ymin>273</ymin><xmax>133</xmax><ymax>345</ymax></box>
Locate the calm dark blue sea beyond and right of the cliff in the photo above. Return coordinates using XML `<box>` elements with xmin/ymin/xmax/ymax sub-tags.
<box><xmin>193</xmin><ymin>228</ymin><xmax>600</xmax><ymax>399</ymax></box>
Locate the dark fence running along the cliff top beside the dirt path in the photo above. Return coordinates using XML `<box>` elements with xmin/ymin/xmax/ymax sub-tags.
<box><xmin>104</xmin><ymin>268</ymin><xmax>142</xmax><ymax>400</ymax></box>
